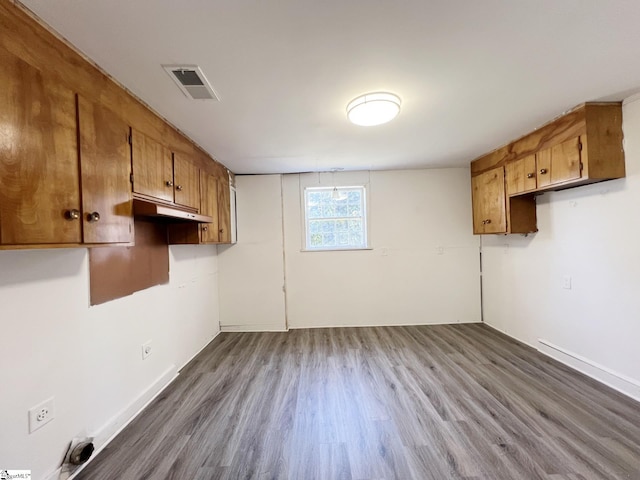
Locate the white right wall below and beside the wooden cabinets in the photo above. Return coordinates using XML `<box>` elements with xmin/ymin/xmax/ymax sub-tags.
<box><xmin>482</xmin><ymin>97</ymin><xmax>640</xmax><ymax>399</ymax></box>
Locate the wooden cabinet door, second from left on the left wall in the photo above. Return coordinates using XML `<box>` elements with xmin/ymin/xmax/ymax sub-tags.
<box><xmin>78</xmin><ymin>96</ymin><xmax>133</xmax><ymax>243</ymax></box>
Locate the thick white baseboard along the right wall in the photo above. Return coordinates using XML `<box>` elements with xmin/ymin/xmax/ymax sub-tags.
<box><xmin>538</xmin><ymin>338</ymin><xmax>640</xmax><ymax>402</ymax></box>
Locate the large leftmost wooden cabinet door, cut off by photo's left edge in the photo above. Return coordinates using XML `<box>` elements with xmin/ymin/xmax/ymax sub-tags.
<box><xmin>0</xmin><ymin>49</ymin><xmax>81</xmax><ymax>245</ymax></box>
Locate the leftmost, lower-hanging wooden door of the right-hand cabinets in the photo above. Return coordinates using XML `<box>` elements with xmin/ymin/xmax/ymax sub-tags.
<box><xmin>471</xmin><ymin>167</ymin><xmax>507</xmax><ymax>233</ymax></box>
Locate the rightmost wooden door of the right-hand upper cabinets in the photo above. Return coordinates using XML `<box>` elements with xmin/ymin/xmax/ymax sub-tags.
<box><xmin>537</xmin><ymin>137</ymin><xmax>582</xmax><ymax>188</ymax></box>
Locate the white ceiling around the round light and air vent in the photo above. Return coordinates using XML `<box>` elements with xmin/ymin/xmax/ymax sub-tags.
<box><xmin>22</xmin><ymin>0</ymin><xmax>640</xmax><ymax>173</ymax></box>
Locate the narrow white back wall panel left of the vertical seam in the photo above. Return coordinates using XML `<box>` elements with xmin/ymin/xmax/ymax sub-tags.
<box><xmin>218</xmin><ymin>175</ymin><xmax>287</xmax><ymax>331</ymax></box>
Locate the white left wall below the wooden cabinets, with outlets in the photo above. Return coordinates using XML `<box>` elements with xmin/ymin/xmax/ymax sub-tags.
<box><xmin>0</xmin><ymin>246</ymin><xmax>218</xmax><ymax>480</ymax></box>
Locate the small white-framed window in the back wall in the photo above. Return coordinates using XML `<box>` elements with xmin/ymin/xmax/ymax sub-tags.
<box><xmin>304</xmin><ymin>187</ymin><xmax>367</xmax><ymax>250</ymax></box>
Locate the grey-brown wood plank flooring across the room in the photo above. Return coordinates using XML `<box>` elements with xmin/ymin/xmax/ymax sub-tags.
<box><xmin>77</xmin><ymin>324</ymin><xmax>640</xmax><ymax>480</ymax></box>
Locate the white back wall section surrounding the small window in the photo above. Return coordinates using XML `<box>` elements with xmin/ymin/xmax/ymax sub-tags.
<box><xmin>283</xmin><ymin>168</ymin><xmax>480</xmax><ymax>328</ymax></box>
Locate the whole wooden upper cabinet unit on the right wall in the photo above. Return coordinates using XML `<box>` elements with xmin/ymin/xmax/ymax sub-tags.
<box><xmin>471</xmin><ymin>102</ymin><xmax>625</xmax><ymax>233</ymax></box>
